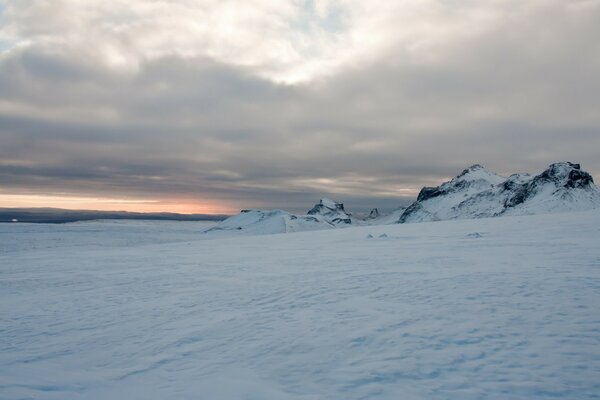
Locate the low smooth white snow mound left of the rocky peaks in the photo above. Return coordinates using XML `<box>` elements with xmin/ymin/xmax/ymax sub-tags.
<box><xmin>204</xmin><ymin>210</ymin><xmax>335</xmax><ymax>236</ymax></box>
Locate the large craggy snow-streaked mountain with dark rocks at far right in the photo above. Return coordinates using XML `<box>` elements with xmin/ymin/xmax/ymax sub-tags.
<box><xmin>397</xmin><ymin>162</ymin><xmax>600</xmax><ymax>223</ymax></box>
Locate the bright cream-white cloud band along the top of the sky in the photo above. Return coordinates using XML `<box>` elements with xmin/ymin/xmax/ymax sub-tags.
<box><xmin>0</xmin><ymin>0</ymin><xmax>576</xmax><ymax>83</ymax></box>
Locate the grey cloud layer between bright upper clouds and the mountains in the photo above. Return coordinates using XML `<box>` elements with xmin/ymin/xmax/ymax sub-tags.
<box><xmin>0</xmin><ymin>1</ymin><xmax>600</xmax><ymax>210</ymax></box>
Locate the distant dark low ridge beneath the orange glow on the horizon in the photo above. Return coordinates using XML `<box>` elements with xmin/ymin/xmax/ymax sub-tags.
<box><xmin>0</xmin><ymin>208</ymin><xmax>228</xmax><ymax>224</ymax></box>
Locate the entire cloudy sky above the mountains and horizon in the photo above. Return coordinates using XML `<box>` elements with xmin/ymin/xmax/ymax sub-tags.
<box><xmin>0</xmin><ymin>0</ymin><xmax>600</xmax><ymax>213</ymax></box>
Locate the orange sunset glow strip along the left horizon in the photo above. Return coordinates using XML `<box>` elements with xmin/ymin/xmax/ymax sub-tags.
<box><xmin>0</xmin><ymin>193</ymin><xmax>239</xmax><ymax>214</ymax></box>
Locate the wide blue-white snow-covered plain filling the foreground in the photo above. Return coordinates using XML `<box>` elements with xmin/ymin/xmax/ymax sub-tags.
<box><xmin>0</xmin><ymin>210</ymin><xmax>600</xmax><ymax>400</ymax></box>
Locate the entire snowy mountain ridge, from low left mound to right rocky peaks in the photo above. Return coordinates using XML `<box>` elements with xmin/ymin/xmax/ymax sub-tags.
<box><xmin>206</xmin><ymin>162</ymin><xmax>600</xmax><ymax>235</ymax></box>
